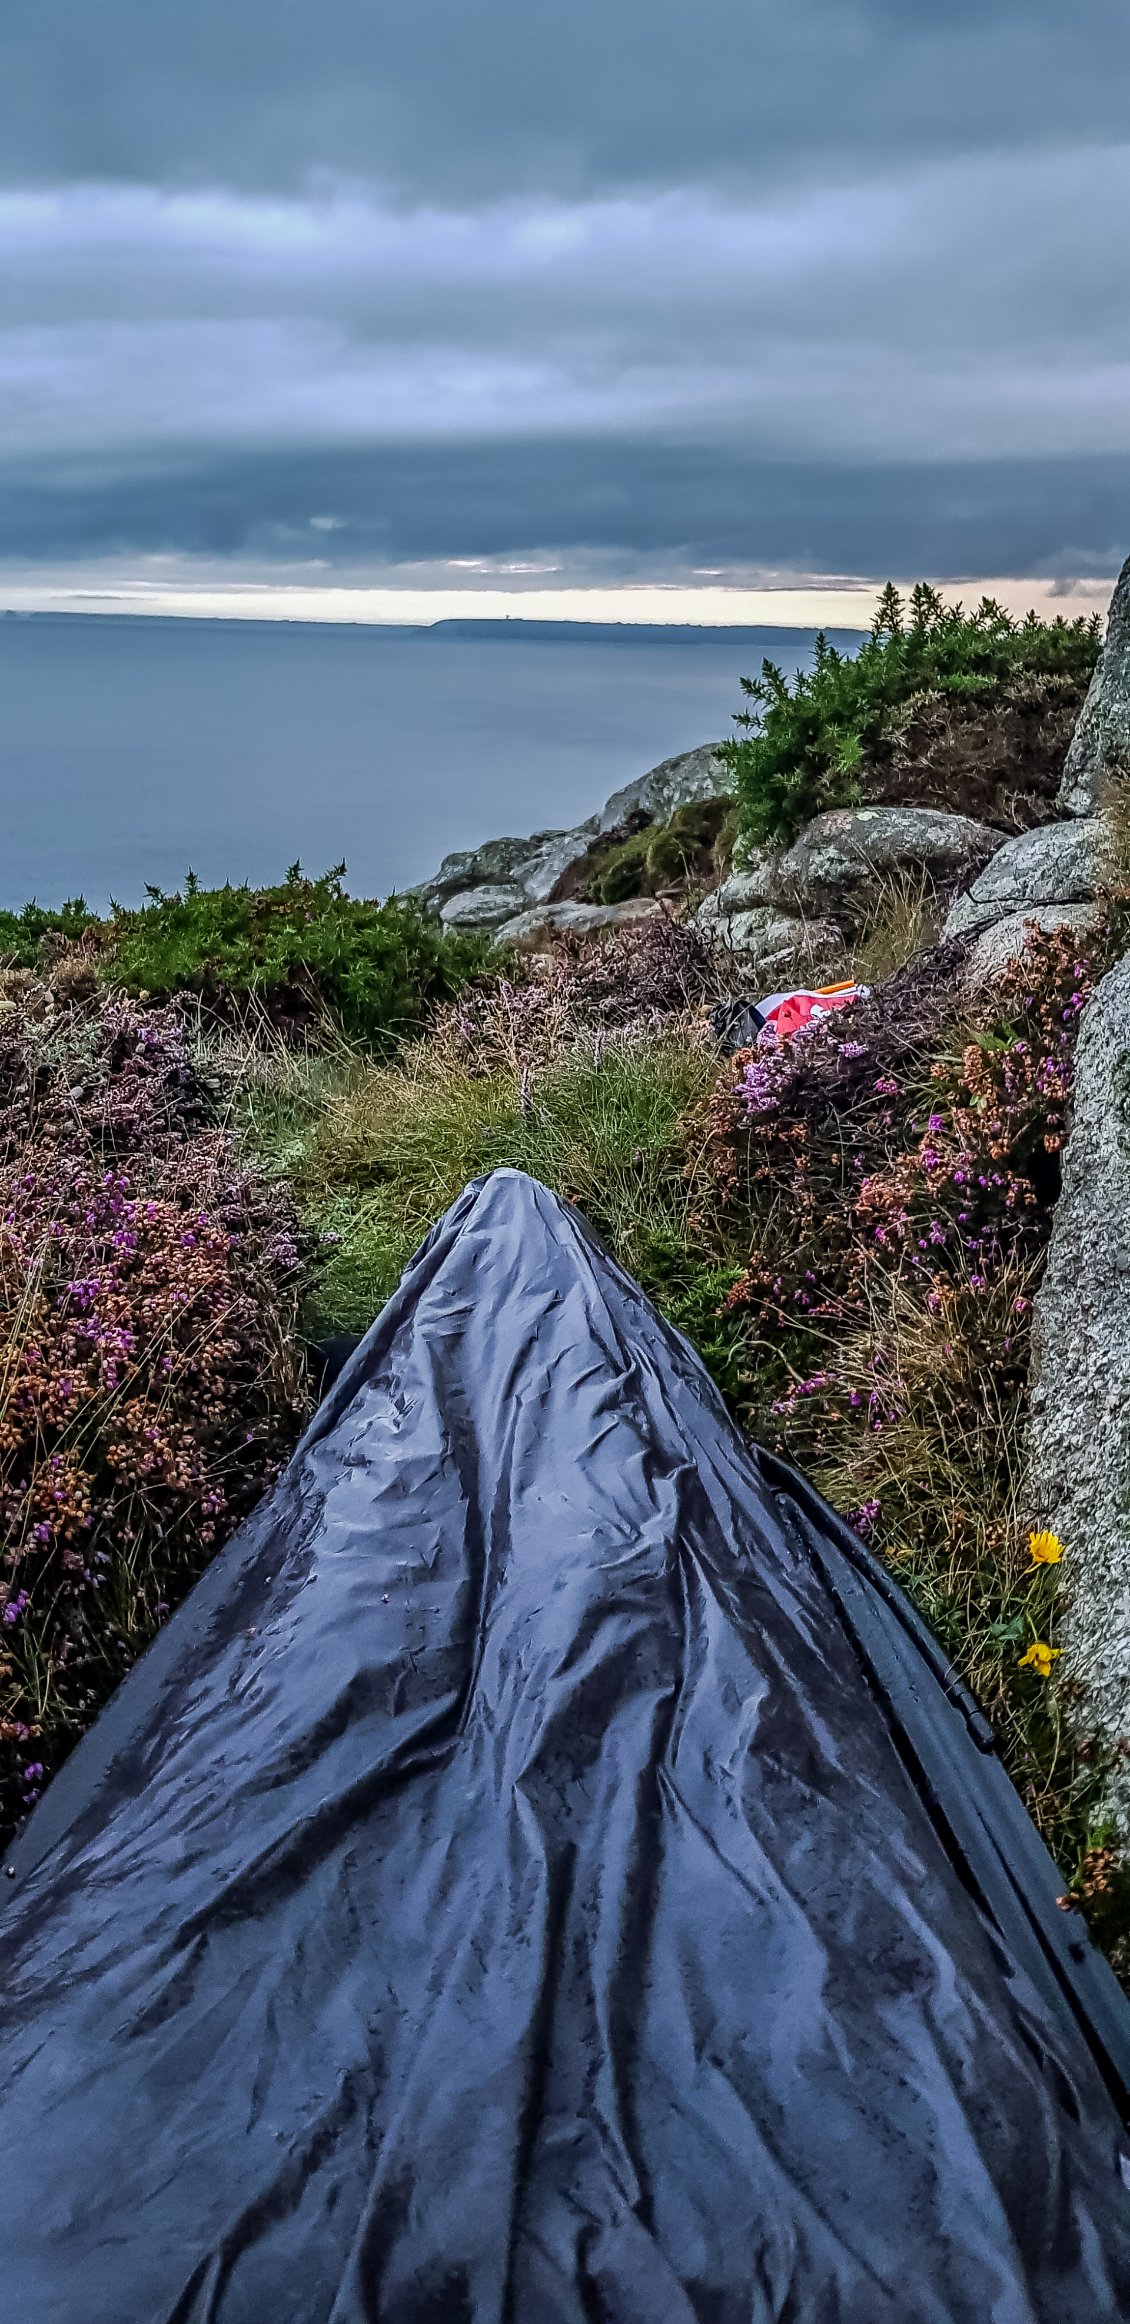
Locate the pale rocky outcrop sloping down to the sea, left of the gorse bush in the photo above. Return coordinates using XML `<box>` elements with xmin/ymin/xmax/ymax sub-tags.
<box><xmin>412</xmin><ymin>744</ymin><xmax>730</xmax><ymax>927</ymax></box>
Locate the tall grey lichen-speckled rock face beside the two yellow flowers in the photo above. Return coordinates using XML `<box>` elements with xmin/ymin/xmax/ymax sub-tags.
<box><xmin>1028</xmin><ymin>957</ymin><xmax>1130</xmax><ymax>1836</ymax></box>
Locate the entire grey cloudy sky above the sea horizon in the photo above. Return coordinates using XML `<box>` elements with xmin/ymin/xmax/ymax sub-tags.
<box><xmin>0</xmin><ymin>0</ymin><xmax>1130</xmax><ymax>602</ymax></box>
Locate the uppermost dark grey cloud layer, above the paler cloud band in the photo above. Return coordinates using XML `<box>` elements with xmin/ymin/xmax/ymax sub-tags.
<box><xmin>0</xmin><ymin>0</ymin><xmax>1130</xmax><ymax>207</ymax></box>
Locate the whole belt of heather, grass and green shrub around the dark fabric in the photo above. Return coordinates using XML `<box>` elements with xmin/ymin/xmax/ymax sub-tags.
<box><xmin>0</xmin><ymin>827</ymin><xmax>1130</xmax><ymax>1973</ymax></box>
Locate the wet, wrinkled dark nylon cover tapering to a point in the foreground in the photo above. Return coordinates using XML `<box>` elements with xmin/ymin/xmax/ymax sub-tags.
<box><xmin>0</xmin><ymin>1171</ymin><xmax>1130</xmax><ymax>2324</ymax></box>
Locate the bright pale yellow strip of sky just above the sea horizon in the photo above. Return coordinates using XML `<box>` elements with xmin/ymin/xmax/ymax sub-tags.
<box><xmin>0</xmin><ymin>574</ymin><xmax>1114</xmax><ymax>630</ymax></box>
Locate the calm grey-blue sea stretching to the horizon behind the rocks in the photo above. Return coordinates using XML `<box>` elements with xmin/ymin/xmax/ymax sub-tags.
<box><xmin>0</xmin><ymin>614</ymin><xmax>860</xmax><ymax>906</ymax></box>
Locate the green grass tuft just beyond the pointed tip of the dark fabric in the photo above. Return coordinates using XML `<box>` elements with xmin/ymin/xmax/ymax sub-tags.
<box><xmin>242</xmin><ymin>1023</ymin><xmax>716</xmax><ymax>1339</ymax></box>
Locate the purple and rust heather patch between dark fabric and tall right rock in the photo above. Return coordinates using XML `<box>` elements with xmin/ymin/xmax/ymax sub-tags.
<box><xmin>711</xmin><ymin>932</ymin><xmax>1130</xmax><ymax>1971</ymax></box>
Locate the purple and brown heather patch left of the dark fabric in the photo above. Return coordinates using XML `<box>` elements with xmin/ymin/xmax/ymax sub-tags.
<box><xmin>0</xmin><ymin>976</ymin><xmax>305</xmax><ymax>1829</ymax></box>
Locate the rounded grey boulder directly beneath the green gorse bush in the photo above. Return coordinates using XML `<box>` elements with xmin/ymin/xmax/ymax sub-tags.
<box><xmin>777</xmin><ymin>806</ymin><xmax>1000</xmax><ymax>925</ymax></box>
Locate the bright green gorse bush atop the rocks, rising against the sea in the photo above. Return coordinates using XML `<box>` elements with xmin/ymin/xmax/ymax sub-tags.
<box><xmin>721</xmin><ymin>581</ymin><xmax>1100</xmax><ymax>846</ymax></box>
